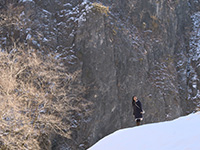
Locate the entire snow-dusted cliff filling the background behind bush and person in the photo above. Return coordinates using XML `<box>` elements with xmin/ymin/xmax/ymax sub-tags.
<box><xmin>0</xmin><ymin>0</ymin><xmax>199</xmax><ymax>149</ymax></box>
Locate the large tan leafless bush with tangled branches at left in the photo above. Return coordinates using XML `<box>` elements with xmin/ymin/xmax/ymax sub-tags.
<box><xmin>0</xmin><ymin>45</ymin><xmax>88</xmax><ymax>150</ymax></box>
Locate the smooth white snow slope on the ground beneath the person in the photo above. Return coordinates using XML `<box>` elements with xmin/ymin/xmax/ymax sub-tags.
<box><xmin>88</xmin><ymin>112</ymin><xmax>200</xmax><ymax>150</ymax></box>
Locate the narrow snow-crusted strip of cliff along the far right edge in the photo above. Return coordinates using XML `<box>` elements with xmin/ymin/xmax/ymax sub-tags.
<box><xmin>187</xmin><ymin>11</ymin><xmax>200</xmax><ymax>109</ymax></box>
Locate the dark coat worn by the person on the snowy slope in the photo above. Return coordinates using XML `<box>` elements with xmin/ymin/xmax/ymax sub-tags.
<box><xmin>132</xmin><ymin>100</ymin><xmax>143</xmax><ymax>119</ymax></box>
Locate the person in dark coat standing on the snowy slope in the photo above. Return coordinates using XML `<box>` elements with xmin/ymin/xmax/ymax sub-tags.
<box><xmin>132</xmin><ymin>96</ymin><xmax>145</xmax><ymax>126</ymax></box>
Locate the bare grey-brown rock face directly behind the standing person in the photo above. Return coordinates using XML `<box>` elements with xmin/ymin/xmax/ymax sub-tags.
<box><xmin>75</xmin><ymin>0</ymin><xmax>198</xmax><ymax>148</ymax></box>
